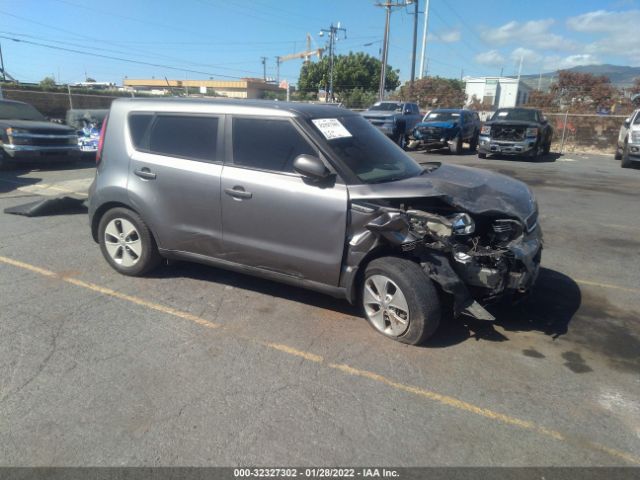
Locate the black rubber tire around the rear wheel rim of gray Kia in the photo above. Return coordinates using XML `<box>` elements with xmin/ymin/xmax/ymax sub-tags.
<box><xmin>98</xmin><ymin>207</ymin><xmax>160</xmax><ymax>276</ymax></box>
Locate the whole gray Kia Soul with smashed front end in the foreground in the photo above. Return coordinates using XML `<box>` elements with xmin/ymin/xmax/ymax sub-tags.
<box><xmin>89</xmin><ymin>99</ymin><xmax>542</xmax><ymax>344</ymax></box>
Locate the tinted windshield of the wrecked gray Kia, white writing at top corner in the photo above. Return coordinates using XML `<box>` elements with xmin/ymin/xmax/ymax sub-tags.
<box><xmin>310</xmin><ymin>115</ymin><xmax>424</xmax><ymax>183</ymax></box>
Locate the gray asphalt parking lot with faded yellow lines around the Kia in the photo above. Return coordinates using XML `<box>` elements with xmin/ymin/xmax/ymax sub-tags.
<box><xmin>0</xmin><ymin>152</ymin><xmax>640</xmax><ymax>466</ymax></box>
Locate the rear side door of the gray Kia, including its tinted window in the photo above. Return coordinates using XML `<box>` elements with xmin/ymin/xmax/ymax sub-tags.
<box><xmin>128</xmin><ymin>112</ymin><xmax>224</xmax><ymax>256</ymax></box>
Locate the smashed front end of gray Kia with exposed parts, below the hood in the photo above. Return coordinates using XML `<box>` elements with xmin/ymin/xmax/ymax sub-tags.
<box><xmin>345</xmin><ymin>198</ymin><xmax>542</xmax><ymax>320</ymax></box>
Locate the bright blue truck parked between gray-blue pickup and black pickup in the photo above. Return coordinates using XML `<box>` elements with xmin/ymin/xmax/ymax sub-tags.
<box><xmin>409</xmin><ymin>109</ymin><xmax>480</xmax><ymax>154</ymax></box>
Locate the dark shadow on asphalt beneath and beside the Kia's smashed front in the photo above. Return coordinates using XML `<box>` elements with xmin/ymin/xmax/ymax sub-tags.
<box><xmin>425</xmin><ymin>268</ymin><xmax>582</xmax><ymax>348</ymax></box>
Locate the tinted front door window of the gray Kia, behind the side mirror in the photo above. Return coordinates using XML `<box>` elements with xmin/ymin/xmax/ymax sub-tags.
<box><xmin>232</xmin><ymin>117</ymin><xmax>318</xmax><ymax>173</ymax></box>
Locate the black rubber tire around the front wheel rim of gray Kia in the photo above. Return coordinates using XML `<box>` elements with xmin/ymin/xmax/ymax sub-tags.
<box><xmin>360</xmin><ymin>257</ymin><xmax>441</xmax><ymax>345</ymax></box>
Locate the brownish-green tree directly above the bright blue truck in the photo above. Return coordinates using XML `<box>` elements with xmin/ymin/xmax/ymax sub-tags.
<box><xmin>397</xmin><ymin>77</ymin><xmax>467</xmax><ymax>110</ymax></box>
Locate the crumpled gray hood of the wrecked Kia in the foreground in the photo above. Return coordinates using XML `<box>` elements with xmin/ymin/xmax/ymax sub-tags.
<box><xmin>349</xmin><ymin>165</ymin><xmax>536</xmax><ymax>223</ymax></box>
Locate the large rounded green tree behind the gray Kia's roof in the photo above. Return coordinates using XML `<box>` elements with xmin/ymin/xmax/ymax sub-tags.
<box><xmin>298</xmin><ymin>52</ymin><xmax>400</xmax><ymax>100</ymax></box>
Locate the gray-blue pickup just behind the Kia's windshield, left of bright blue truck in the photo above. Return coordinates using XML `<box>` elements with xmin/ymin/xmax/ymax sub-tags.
<box><xmin>362</xmin><ymin>101</ymin><xmax>422</xmax><ymax>148</ymax></box>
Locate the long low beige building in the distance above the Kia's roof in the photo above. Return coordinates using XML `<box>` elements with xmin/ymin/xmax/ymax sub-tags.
<box><xmin>122</xmin><ymin>78</ymin><xmax>286</xmax><ymax>98</ymax></box>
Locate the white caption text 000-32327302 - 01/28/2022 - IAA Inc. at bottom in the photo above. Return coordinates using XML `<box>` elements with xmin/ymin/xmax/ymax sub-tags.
<box><xmin>233</xmin><ymin>468</ymin><xmax>398</xmax><ymax>478</ymax></box>
